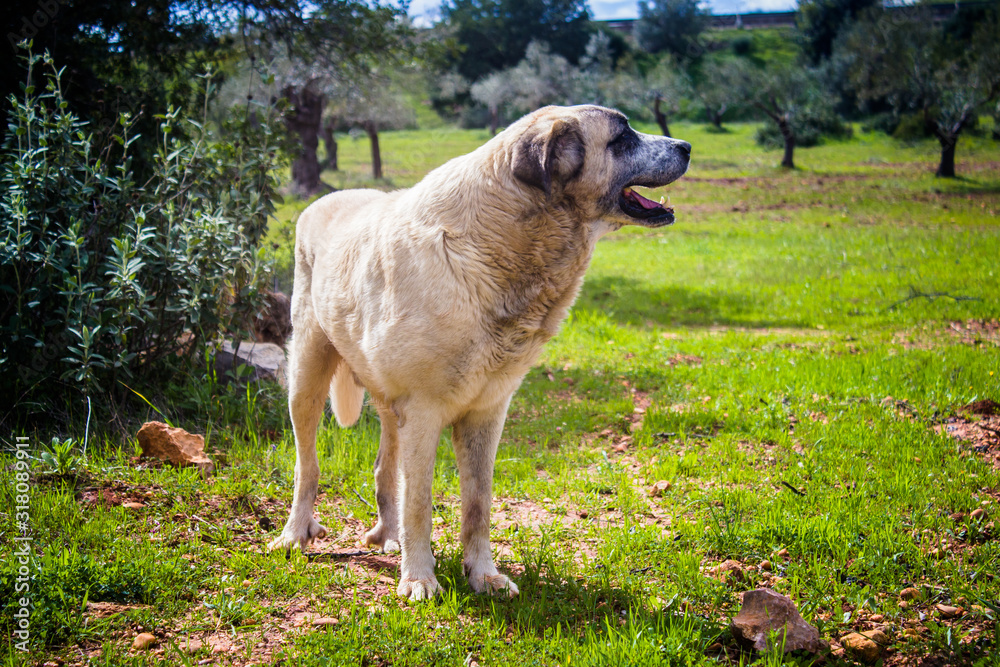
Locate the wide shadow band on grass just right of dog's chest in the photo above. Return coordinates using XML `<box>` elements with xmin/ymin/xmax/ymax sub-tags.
<box><xmin>573</xmin><ymin>276</ymin><xmax>812</xmax><ymax>329</ymax></box>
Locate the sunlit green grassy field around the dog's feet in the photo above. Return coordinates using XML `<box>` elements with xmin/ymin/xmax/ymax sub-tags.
<box><xmin>0</xmin><ymin>117</ymin><xmax>1000</xmax><ymax>666</ymax></box>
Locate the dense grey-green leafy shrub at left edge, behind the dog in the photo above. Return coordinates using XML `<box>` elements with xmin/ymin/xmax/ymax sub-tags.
<box><xmin>0</xmin><ymin>54</ymin><xmax>277</xmax><ymax>422</ymax></box>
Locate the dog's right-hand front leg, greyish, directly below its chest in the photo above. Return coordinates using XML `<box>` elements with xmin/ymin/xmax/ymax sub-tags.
<box><xmin>452</xmin><ymin>397</ymin><xmax>518</xmax><ymax>597</ymax></box>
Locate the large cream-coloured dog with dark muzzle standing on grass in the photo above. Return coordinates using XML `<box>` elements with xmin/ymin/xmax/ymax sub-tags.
<box><xmin>269</xmin><ymin>106</ymin><xmax>691</xmax><ymax>600</ymax></box>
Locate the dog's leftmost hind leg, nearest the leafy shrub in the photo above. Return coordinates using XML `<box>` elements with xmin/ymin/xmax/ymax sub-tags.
<box><xmin>268</xmin><ymin>320</ymin><xmax>339</xmax><ymax>550</ymax></box>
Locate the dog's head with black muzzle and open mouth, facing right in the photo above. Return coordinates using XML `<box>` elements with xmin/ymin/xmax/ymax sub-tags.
<box><xmin>508</xmin><ymin>106</ymin><xmax>691</xmax><ymax>227</ymax></box>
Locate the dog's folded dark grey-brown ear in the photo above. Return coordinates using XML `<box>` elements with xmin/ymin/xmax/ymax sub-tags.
<box><xmin>513</xmin><ymin>118</ymin><xmax>585</xmax><ymax>196</ymax></box>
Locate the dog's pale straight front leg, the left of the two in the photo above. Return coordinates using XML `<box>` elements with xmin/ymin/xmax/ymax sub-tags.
<box><xmin>396</xmin><ymin>415</ymin><xmax>441</xmax><ymax>600</ymax></box>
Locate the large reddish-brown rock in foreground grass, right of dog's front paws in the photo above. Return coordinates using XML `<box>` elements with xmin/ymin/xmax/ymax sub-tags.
<box><xmin>730</xmin><ymin>588</ymin><xmax>828</xmax><ymax>653</ymax></box>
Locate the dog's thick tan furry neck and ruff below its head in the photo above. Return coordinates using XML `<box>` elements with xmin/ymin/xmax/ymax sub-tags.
<box><xmin>412</xmin><ymin>152</ymin><xmax>617</xmax><ymax>348</ymax></box>
